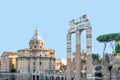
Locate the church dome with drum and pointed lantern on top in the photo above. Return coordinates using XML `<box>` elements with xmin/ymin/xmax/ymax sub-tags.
<box><xmin>29</xmin><ymin>29</ymin><xmax>44</xmax><ymax>50</ymax></box>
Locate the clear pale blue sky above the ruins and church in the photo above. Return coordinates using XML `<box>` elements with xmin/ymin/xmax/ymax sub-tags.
<box><xmin>0</xmin><ymin>0</ymin><xmax>120</xmax><ymax>58</ymax></box>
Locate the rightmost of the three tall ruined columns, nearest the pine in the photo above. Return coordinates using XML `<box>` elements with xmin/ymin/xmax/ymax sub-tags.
<box><xmin>86</xmin><ymin>27</ymin><xmax>93</xmax><ymax>78</ymax></box>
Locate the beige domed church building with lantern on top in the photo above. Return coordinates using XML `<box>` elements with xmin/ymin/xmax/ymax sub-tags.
<box><xmin>16</xmin><ymin>29</ymin><xmax>56</xmax><ymax>73</ymax></box>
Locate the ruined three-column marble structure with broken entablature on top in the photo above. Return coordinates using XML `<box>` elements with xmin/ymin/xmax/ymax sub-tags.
<box><xmin>67</xmin><ymin>15</ymin><xmax>92</xmax><ymax>80</ymax></box>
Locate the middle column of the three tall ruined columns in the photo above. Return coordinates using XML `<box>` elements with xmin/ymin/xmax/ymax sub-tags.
<box><xmin>76</xmin><ymin>31</ymin><xmax>81</xmax><ymax>80</ymax></box>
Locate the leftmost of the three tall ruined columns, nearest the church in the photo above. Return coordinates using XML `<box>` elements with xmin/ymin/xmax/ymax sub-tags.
<box><xmin>67</xmin><ymin>33</ymin><xmax>72</xmax><ymax>80</ymax></box>
